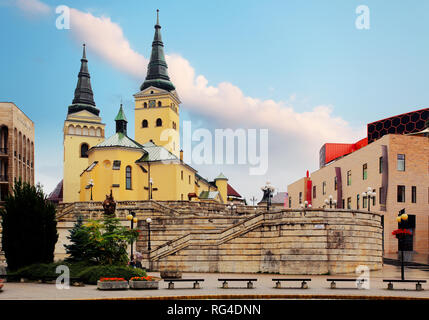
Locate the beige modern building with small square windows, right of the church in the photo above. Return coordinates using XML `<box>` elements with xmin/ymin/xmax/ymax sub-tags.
<box><xmin>288</xmin><ymin>109</ymin><xmax>429</xmax><ymax>260</ymax></box>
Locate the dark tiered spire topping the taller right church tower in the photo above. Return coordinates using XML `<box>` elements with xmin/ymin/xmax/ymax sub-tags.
<box><xmin>140</xmin><ymin>10</ymin><xmax>176</xmax><ymax>91</ymax></box>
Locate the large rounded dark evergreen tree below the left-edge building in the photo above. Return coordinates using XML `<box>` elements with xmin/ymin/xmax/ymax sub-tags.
<box><xmin>0</xmin><ymin>180</ymin><xmax>58</xmax><ymax>270</ymax></box>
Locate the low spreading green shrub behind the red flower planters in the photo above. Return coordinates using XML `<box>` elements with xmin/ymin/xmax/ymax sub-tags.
<box><xmin>77</xmin><ymin>265</ymin><xmax>146</xmax><ymax>284</ymax></box>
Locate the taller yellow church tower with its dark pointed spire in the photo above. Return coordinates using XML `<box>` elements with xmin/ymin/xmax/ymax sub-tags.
<box><xmin>134</xmin><ymin>10</ymin><xmax>181</xmax><ymax>157</ymax></box>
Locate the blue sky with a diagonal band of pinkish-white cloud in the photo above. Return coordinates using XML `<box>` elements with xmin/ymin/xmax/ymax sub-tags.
<box><xmin>0</xmin><ymin>0</ymin><xmax>429</xmax><ymax>202</ymax></box>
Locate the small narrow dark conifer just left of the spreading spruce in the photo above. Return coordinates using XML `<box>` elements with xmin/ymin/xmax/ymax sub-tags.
<box><xmin>64</xmin><ymin>216</ymin><xmax>90</xmax><ymax>262</ymax></box>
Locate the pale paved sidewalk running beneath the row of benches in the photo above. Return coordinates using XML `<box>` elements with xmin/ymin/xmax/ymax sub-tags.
<box><xmin>0</xmin><ymin>265</ymin><xmax>429</xmax><ymax>300</ymax></box>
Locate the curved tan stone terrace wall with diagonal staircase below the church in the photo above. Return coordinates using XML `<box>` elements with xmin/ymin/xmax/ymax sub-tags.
<box><xmin>56</xmin><ymin>201</ymin><xmax>382</xmax><ymax>274</ymax></box>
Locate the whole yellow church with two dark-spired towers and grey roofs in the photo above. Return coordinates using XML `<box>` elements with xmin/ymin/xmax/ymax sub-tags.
<box><xmin>52</xmin><ymin>11</ymin><xmax>243</xmax><ymax>203</ymax></box>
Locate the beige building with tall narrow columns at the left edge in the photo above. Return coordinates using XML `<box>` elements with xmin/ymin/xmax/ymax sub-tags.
<box><xmin>0</xmin><ymin>102</ymin><xmax>34</xmax><ymax>201</ymax></box>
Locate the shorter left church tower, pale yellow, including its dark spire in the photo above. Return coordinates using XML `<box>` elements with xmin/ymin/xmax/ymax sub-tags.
<box><xmin>63</xmin><ymin>44</ymin><xmax>105</xmax><ymax>202</ymax></box>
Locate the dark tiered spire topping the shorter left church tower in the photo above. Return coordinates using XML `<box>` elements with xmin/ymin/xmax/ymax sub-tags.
<box><xmin>69</xmin><ymin>44</ymin><xmax>100</xmax><ymax>116</ymax></box>
